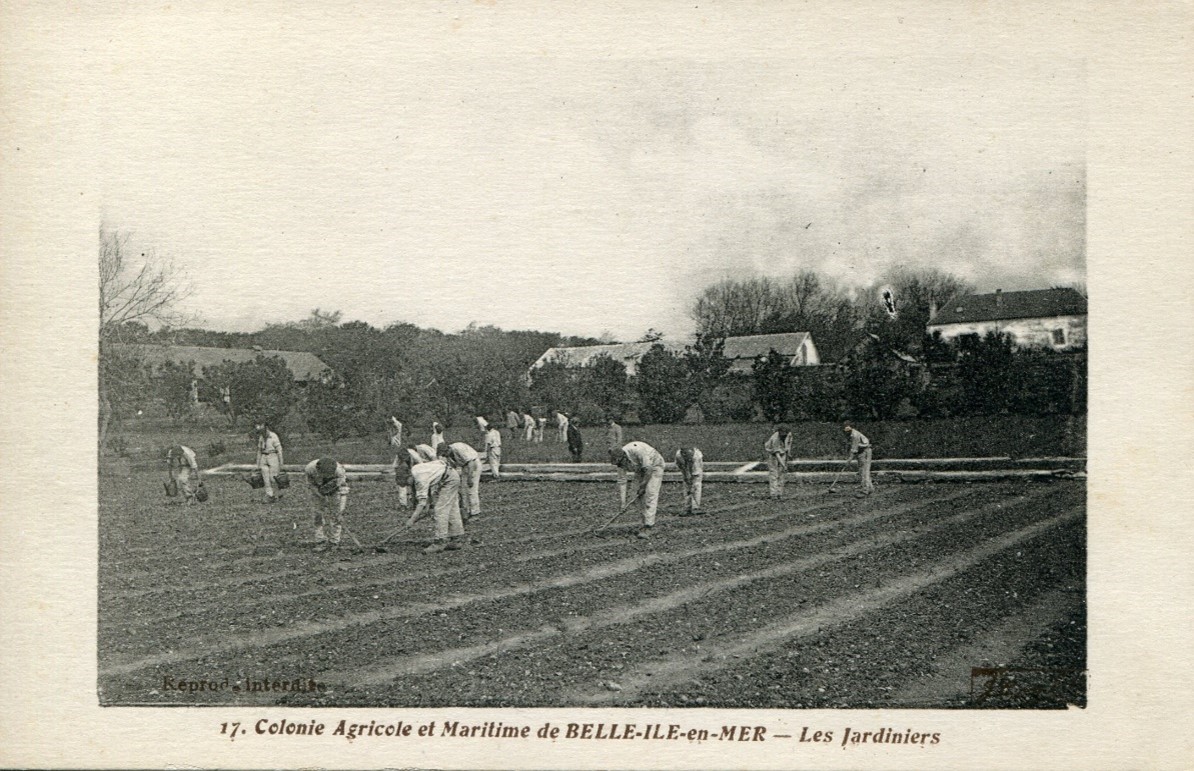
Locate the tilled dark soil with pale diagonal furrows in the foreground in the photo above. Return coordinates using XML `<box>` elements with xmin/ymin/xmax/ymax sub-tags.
<box><xmin>99</xmin><ymin>475</ymin><xmax>1085</xmax><ymax>708</ymax></box>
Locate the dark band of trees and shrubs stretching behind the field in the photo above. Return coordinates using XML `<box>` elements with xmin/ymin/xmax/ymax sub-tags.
<box><xmin>99</xmin><ymin>226</ymin><xmax>1085</xmax><ymax>451</ymax></box>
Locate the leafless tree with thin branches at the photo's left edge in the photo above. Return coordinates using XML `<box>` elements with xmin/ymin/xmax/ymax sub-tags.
<box><xmin>99</xmin><ymin>226</ymin><xmax>191</xmax><ymax>448</ymax></box>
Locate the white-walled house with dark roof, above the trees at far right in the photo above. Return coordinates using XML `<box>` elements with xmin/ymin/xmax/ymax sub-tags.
<box><xmin>927</xmin><ymin>289</ymin><xmax>1087</xmax><ymax>351</ymax></box>
